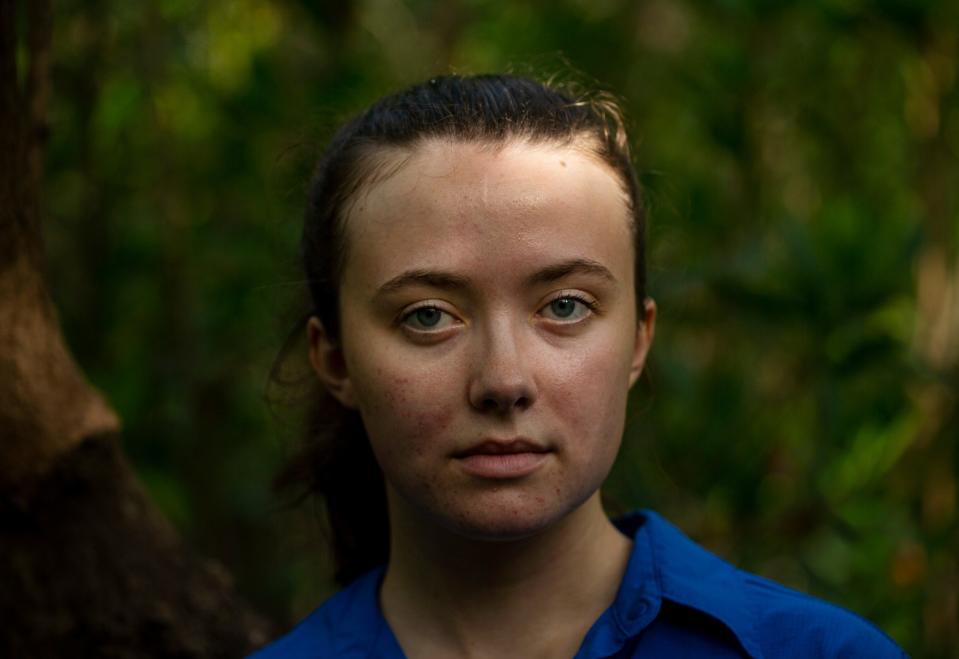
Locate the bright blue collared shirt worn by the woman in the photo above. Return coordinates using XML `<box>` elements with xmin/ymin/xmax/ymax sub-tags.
<box><xmin>249</xmin><ymin>511</ymin><xmax>906</xmax><ymax>659</ymax></box>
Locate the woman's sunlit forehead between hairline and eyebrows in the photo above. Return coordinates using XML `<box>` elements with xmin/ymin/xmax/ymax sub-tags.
<box><xmin>343</xmin><ymin>140</ymin><xmax>633</xmax><ymax>288</ymax></box>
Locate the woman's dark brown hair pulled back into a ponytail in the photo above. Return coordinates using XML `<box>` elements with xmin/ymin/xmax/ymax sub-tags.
<box><xmin>277</xmin><ymin>75</ymin><xmax>646</xmax><ymax>584</ymax></box>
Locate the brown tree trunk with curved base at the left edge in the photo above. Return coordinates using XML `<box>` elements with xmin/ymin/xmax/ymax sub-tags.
<box><xmin>0</xmin><ymin>0</ymin><xmax>269</xmax><ymax>657</ymax></box>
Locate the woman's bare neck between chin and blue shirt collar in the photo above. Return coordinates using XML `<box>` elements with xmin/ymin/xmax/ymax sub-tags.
<box><xmin>380</xmin><ymin>492</ymin><xmax>631</xmax><ymax>658</ymax></box>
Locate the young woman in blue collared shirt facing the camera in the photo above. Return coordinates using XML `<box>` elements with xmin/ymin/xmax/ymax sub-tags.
<box><xmin>251</xmin><ymin>76</ymin><xmax>902</xmax><ymax>659</ymax></box>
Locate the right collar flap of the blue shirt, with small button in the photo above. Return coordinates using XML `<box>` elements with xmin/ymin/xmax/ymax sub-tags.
<box><xmin>612</xmin><ymin>510</ymin><xmax>763</xmax><ymax>659</ymax></box>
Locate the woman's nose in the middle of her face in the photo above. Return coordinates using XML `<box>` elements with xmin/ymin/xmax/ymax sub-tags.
<box><xmin>469</xmin><ymin>322</ymin><xmax>537</xmax><ymax>414</ymax></box>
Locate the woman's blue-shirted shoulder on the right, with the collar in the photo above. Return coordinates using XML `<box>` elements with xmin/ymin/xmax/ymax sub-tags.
<box><xmin>631</xmin><ymin>511</ymin><xmax>905</xmax><ymax>659</ymax></box>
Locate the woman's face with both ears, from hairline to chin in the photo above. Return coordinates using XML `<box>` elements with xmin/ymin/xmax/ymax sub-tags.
<box><xmin>310</xmin><ymin>140</ymin><xmax>655</xmax><ymax>539</ymax></box>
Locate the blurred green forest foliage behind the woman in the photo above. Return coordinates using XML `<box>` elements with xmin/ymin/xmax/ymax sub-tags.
<box><xmin>46</xmin><ymin>0</ymin><xmax>959</xmax><ymax>657</ymax></box>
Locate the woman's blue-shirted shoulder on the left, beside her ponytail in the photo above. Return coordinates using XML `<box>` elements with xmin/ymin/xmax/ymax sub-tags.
<box><xmin>250</xmin><ymin>568</ymin><xmax>383</xmax><ymax>659</ymax></box>
